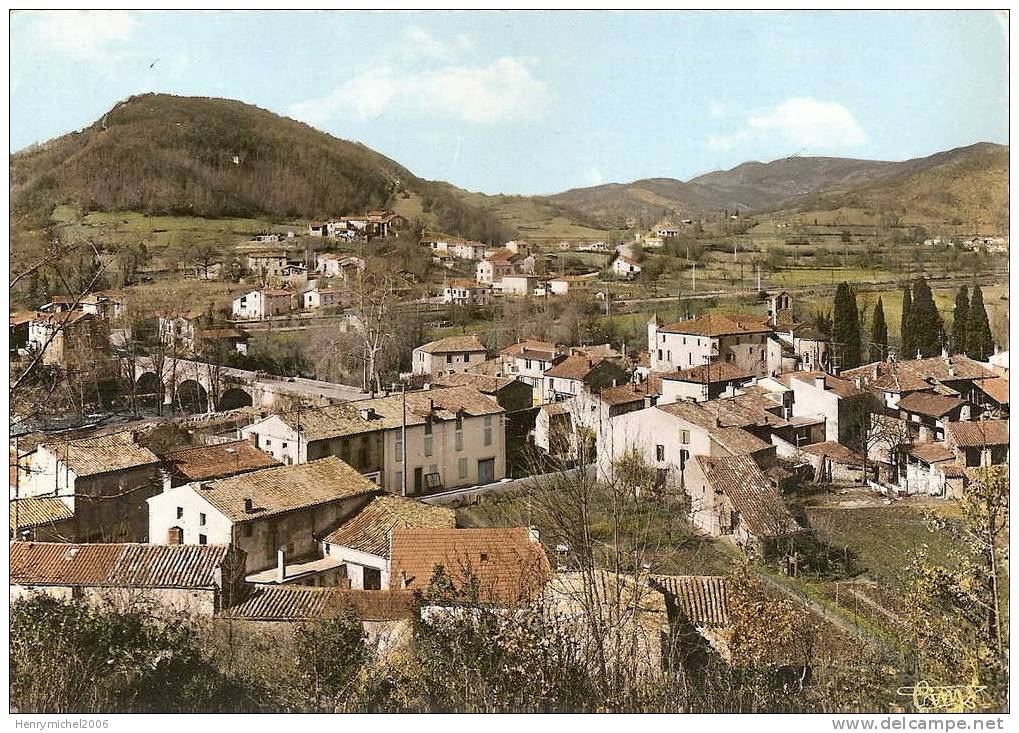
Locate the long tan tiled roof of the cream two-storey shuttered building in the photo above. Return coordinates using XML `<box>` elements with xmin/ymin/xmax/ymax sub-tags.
<box><xmin>260</xmin><ymin>386</ymin><xmax>504</xmax><ymax>440</ymax></box>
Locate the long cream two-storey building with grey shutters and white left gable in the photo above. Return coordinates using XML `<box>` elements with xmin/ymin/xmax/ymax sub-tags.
<box><xmin>239</xmin><ymin>386</ymin><xmax>505</xmax><ymax>493</ymax></box>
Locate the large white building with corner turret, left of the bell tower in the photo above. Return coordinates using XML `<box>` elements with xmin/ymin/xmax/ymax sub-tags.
<box><xmin>647</xmin><ymin>313</ymin><xmax>781</xmax><ymax>376</ymax></box>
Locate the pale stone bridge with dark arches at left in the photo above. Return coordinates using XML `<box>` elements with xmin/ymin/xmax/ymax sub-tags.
<box><xmin>132</xmin><ymin>357</ymin><xmax>369</xmax><ymax>414</ymax></box>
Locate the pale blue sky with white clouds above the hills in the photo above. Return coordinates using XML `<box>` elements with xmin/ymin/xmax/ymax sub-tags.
<box><xmin>10</xmin><ymin>11</ymin><xmax>1008</xmax><ymax>194</ymax></box>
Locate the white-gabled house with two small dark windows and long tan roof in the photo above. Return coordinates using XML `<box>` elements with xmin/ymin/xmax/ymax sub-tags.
<box><xmin>148</xmin><ymin>457</ymin><xmax>379</xmax><ymax>579</ymax></box>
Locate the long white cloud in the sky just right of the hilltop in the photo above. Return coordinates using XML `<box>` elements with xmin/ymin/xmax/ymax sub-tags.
<box><xmin>288</xmin><ymin>57</ymin><xmax>548</xmax><ymax>124</ymax></box>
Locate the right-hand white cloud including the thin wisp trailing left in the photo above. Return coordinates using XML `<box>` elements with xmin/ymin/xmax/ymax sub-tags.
<box><xmin>706</xmin><ymin>97</ymin><xmax>867</xmax><ymax>153</ymax></box>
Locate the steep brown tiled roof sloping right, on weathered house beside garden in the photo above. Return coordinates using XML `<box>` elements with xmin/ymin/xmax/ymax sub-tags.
<box><xmin>694</xmin><ymin>456</ymin><xmax>800</xmax><ymax>537</ymax></box>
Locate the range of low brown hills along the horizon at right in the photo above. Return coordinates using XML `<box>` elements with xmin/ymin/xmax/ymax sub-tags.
<box><xmin>547</xmin><ymin>143</ymin><xmax>1008</xmax><ymax>226</ymax></box>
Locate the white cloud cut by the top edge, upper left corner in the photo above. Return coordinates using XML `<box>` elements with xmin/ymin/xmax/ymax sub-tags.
<box><xmin>33</xmin><ymin>10</ymin><xmax>139</xmax><ymax>60</ymax></box>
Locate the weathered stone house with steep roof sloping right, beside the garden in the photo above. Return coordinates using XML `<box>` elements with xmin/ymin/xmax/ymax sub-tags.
<box><xmin>685</xmin><ymin>456</ymin><xmax>802</xmax><ymax>557</ymax></box>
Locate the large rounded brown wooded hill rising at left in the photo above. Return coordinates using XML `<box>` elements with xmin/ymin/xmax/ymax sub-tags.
<box><xmin>10</xmin><ymin>94</ymin><xmax>515</xmax><ymax>239</ymax></box>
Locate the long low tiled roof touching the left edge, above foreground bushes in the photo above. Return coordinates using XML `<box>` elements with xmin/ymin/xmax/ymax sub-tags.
<box><xmin>10</xmin><ymin>542</ymin><xmax>229</xmax><ymax>588</ymax></box>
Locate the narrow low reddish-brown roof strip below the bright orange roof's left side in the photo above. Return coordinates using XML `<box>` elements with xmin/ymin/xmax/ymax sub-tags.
<box><xmin>222</xmin><ymin>585</ymin><xmax>417</xmax><ymax>621</ymax></box>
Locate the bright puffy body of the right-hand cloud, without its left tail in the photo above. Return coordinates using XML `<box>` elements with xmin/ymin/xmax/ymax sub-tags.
<box><xmin>748</xmin><ymin>97</ymin><xmax>867</xmax><ymax>149</ymax></box>
